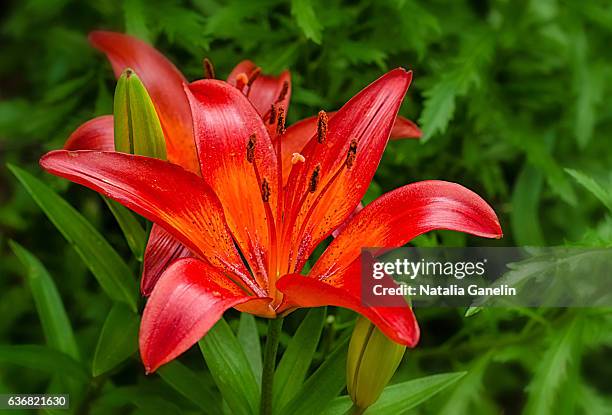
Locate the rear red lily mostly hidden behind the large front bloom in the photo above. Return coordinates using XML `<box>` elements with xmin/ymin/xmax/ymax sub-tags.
<box><xmin>64</xmin><ymin>32</ymin><xmax>421</xmax><ymax>295</ymax></box>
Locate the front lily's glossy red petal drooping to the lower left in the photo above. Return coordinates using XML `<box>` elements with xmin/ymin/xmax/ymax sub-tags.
<box><xmin>139</xmin><ymin>258</ymin><xmax>257</xmax><ymax>373</ymax></box>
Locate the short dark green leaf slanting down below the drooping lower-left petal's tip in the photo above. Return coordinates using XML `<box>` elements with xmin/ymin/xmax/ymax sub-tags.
<box><xmin>157</xmin><ymin>360</ymin><xmax>222</xmax><ymax>415</ymax></box>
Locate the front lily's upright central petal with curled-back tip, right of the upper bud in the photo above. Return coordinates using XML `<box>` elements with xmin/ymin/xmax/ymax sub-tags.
<box><xmin>187</xmin><ymin>79</ymin><xmax>279</xmax><ymax>290</ymax></box>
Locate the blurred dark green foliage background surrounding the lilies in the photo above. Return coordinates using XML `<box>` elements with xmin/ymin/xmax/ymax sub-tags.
<box><xmin>0</xmin><ymin>0</ymin><xmax>612</xmax><ymax>414</ymax></box>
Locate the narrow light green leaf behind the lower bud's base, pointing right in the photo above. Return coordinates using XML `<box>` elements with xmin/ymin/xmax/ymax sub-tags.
<box><xmin>323</xmin><ymin>372</ymin><xmax>466</xmax><ymax>415</ymax></box>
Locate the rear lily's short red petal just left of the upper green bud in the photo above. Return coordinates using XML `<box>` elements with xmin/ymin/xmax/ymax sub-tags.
<box><xmin>64</xmin><ymin>115</ymin><xmax>115</xmax><ymax>151</ymax></box>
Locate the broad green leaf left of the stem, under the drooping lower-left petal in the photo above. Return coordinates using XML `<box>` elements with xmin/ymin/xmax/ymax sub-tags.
<box><xmin>199</xmin><ymin>318</ymin><xmax>259</xmax><ymax>415</ymax></box>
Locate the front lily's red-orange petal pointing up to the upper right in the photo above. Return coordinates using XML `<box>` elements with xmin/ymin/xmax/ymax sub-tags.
<box><xmin>285</xmin><ymin>68</ymin><xmax>412</xmax><ymax>272</ymax></box>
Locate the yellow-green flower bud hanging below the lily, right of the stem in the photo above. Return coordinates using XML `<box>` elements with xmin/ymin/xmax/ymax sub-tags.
<box><xmin>346</xmin><ymin>317</ymin><xmax>406</xmax><ymax>410</ymax></box>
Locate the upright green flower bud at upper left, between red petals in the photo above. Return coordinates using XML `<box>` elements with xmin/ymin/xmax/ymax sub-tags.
<box><xmin>113</xmin><ymin>68</ymin><xmax>166</xmax><ymax>160</ymax></box>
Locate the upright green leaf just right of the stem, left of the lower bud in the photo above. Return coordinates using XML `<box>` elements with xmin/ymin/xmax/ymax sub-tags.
<box><xmin>274</xmin><ymin>307</ymin><xmax>326</xmax><ymax>408</ymax></box>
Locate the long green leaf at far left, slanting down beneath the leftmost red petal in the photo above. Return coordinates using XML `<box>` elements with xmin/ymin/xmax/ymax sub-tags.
<box><xmin>8</xmin><ymin>165</ymin><xmax>138</xmax><ymax>312</ymax></box>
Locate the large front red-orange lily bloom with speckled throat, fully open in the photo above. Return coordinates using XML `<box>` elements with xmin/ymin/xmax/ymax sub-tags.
<box><xmin>41</xmin><ymin>62</ymin><xmax>501</xmax><ymax>372</ymax></box>
